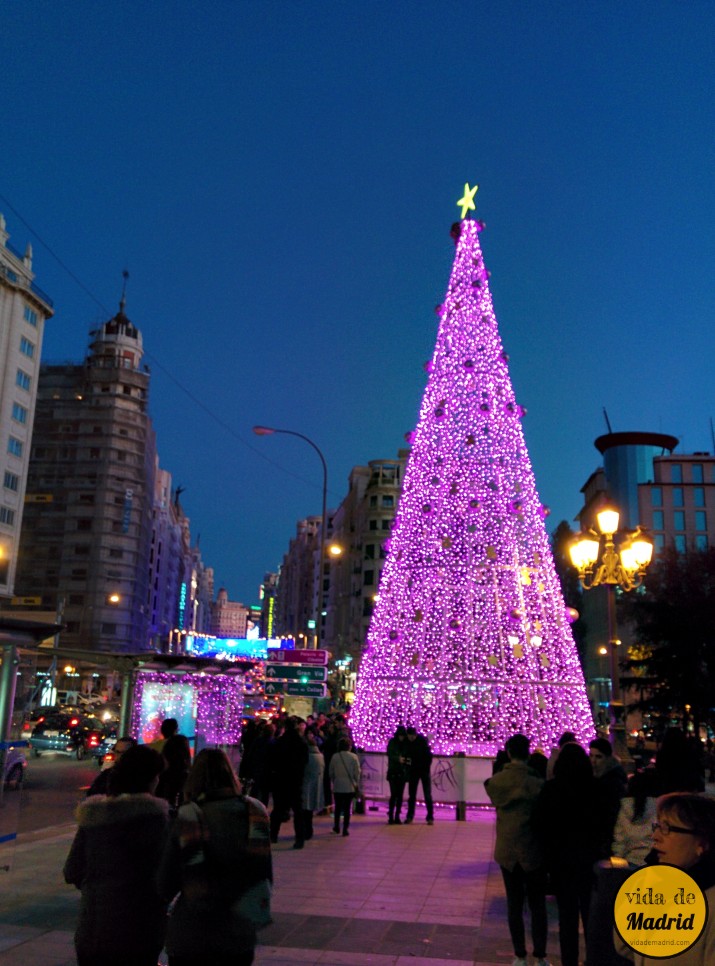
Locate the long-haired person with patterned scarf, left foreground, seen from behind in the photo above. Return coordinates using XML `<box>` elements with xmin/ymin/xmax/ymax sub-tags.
<box><xmin>158</xmin><ymin>748</ymin><xmax>273</xmax><ymax>966</ymax></box>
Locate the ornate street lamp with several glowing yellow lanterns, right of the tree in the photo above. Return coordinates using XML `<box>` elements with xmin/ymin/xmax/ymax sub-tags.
<box><xmin>569</xmin><ymin>506</ymin><xmax>653</xmax><ymax>740</ymax></box>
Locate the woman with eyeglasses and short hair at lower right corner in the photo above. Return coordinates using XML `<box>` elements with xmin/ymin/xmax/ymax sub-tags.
<box><xmin>616</xmin><ymin>792</ymin><xmax>715</xmax><ymax>966</ymax></box>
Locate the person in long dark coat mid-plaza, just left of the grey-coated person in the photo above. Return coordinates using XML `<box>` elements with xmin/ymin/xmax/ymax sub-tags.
<box><xmin>271</xmin><ymin>718</ymin><xmax>308</xmax><ymax>849</ymax></box>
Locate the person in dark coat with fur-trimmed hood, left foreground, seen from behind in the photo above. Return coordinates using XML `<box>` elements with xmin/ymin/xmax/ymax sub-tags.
<box><xmin>64</xmin><ymin>745</ymin><xmax>169</xmax><ymax>966</ymax></box>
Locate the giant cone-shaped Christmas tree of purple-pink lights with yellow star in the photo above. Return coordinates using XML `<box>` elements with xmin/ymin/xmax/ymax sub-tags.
<box><xmin>351</xmin><ymin>185</ymin><xmax>593</xmax><ymax>755</ymax></box>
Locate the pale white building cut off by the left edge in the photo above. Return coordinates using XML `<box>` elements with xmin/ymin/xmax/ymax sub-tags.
<box><xmin>0</xmin><ymin>214</ymin><xmax>53</xmax><ymax>598</ymax></box>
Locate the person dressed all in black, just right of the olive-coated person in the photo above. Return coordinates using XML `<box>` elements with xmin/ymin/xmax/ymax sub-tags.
<box><xmin>533</xmin><ymin>743</ymin><xmax>599</xmax><ymax>966</ymax></box>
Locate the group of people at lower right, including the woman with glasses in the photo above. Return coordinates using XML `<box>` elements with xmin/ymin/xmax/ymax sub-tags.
<box><xmin>485</xmin><ymin>728</ymin><xmax>715</xmax><ymax>966</ymax></box>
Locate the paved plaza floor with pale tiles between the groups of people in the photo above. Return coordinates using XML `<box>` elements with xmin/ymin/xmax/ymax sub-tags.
<box><xmin>0</xmin><ymin>806</ymin><xmax>576</xmax><ymax>966</ymax></box>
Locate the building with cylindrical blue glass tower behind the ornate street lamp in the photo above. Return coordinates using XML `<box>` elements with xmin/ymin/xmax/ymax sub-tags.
<box><xmin>578</xmin><ymin>432</ymin><xmax>715</xmax><ymax>714</ymax></box>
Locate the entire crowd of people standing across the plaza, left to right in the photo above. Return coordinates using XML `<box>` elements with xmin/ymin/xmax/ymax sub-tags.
<box><xmin>64</xmin><ymin>714</ymin><xmax>715</xmax><ymax>966</ymax></box>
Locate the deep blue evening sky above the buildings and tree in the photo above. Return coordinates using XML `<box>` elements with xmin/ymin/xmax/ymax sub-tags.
<box><xmin>0</xmin><ymin>0</ymin><xmax>715</xmax><ymax>602</ymax></box>
